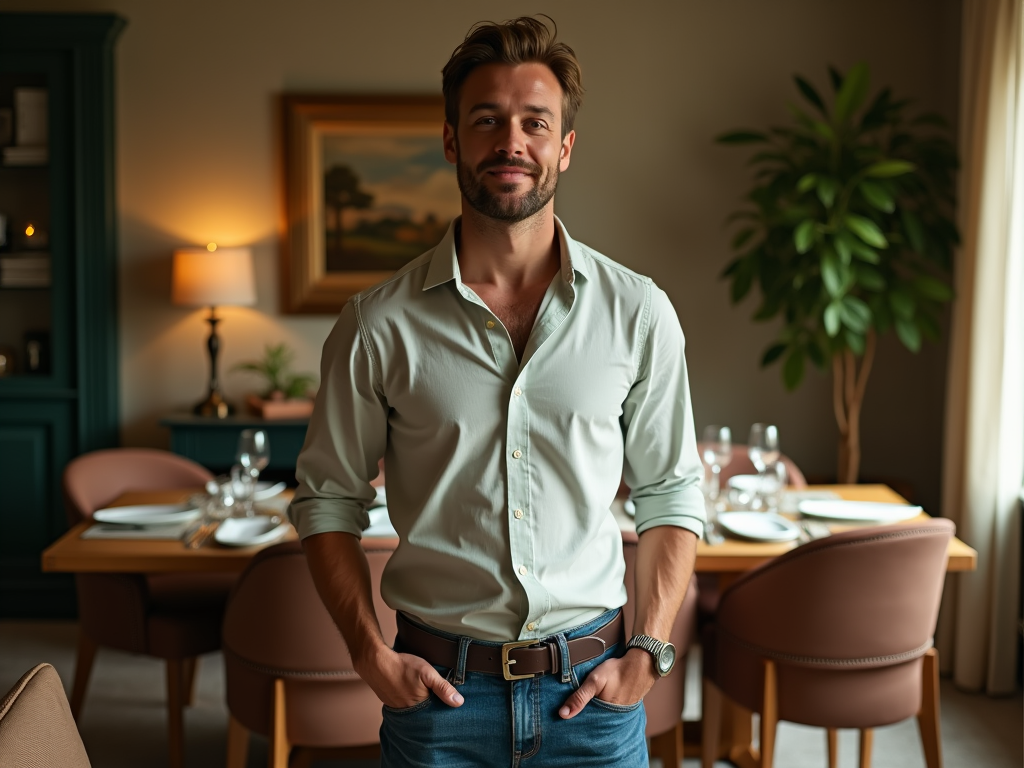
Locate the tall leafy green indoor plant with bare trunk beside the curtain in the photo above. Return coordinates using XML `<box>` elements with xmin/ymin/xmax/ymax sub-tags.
<box><xmin>717</xmin><ymin>63</ymin><xmax>958</xmax><ymax>482</ymax></box>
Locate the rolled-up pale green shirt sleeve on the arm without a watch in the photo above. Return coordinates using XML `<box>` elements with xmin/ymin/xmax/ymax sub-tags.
<box><xmin>288</xmin><ymin>299</ymin><xmax>388</xmax><ymax>539</ymax></box>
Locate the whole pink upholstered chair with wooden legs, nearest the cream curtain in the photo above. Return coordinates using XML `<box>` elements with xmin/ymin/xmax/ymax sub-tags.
<box><xmin>702</xmin><ymin>519</ymin><xmax>954</xmax><ymax>768</ymax></box>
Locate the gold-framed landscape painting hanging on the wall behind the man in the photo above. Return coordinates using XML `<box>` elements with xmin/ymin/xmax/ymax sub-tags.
<box><xmin>281</xmin><ymin>95</ymin><xmax>461</xmax><ymax>314</ymax></box>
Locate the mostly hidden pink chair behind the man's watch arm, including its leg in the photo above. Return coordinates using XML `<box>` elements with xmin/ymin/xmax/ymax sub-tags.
<box><xmin>623</xmin><ymin>530</ymin><xmax>697</xmax><ymax>768</ymax></box>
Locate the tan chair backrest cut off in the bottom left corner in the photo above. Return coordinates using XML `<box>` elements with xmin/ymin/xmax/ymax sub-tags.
<box><xmin>0</xmin><ymin>664</ymin><xmax>90</xmax><ymax>768</ymax></box>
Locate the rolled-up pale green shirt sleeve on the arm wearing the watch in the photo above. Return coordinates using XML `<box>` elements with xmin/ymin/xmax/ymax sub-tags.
<box><xmin>623</xmin><ymin>285</ymin><xmax>706</xmax><ymax>537</ymax></box>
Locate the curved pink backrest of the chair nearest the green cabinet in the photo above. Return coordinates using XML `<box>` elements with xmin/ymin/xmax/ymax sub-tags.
<box><xmin>63</xmin><ymin>449</ymin><xmax>213</xmax><ymax>525</ymax></box>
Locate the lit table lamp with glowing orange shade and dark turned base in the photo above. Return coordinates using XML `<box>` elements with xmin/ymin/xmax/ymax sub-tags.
<box><xmin>171</xmin><ymin>243</ymin><xmax>256</xmax><ymax>419</ymax></box>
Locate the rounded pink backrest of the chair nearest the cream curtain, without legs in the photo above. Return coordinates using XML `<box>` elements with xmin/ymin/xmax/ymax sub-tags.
<box><xmin>718</xmin><ymin>519</ymin><xmax>954</xmax><ymax>670</ymax></box>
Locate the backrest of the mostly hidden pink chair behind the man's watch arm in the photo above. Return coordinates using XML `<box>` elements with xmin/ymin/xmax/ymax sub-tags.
<box><xmin>623</xmin><ymin>530</ymin><xmax>697</xmax><ymax>737</ymax></box>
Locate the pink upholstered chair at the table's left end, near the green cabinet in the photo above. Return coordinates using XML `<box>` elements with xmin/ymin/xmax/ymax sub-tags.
<box><xmin>63</xmin><ymin>449</ymin><xmax>237</xmax><ymax>768</ymax></box>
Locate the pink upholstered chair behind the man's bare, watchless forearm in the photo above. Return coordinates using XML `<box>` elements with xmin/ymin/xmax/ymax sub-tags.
<box><xmin>223</xmin><ymin>539</ymin><xmax>398</xmax><ymax>768</ymax></box>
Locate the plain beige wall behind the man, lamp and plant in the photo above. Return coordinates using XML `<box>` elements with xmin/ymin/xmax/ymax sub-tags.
<box><xmin>0</xmin><ymin>0</ymin><xmax>959</xmax><ymax>518</ymax></box>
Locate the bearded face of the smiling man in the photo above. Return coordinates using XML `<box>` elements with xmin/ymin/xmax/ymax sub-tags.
<box><xmin>444</xmin><ymin>63</ymin><xmax>575</xmax><ymax>222</ymax></box>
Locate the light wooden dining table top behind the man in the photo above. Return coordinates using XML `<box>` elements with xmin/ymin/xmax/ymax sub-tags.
<box><xmin>42</xmin><ymin>485</ymin><xmax>977</xmax><ymax>573</ymax></box>
